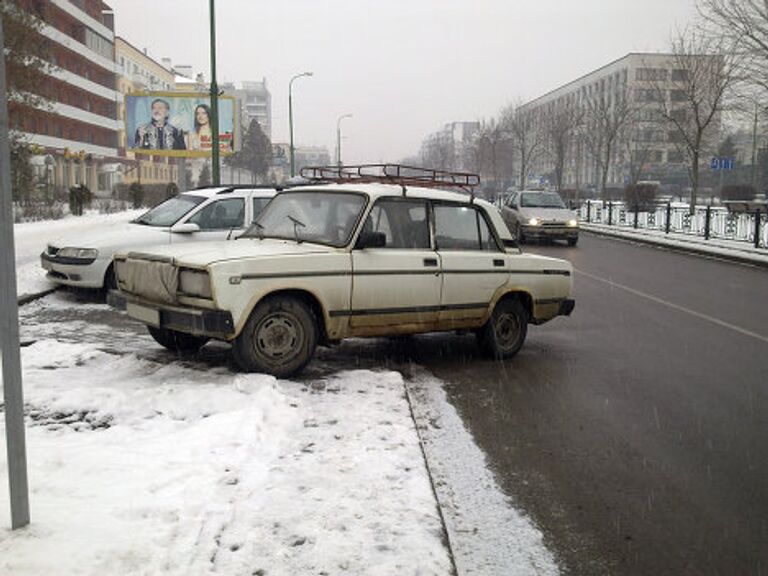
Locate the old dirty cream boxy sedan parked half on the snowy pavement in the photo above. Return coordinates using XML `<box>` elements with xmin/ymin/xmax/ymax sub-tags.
<box><xmin>109</xmin><ymin>183</ymin><xmax>574</xmax><ymax>377</ymax></box>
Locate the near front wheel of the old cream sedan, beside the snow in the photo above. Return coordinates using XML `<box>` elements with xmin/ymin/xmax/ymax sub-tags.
<box><xmin>232</xmin><ymin>296</ymin><xmax>319</xmax><ymax>378</ymax></box>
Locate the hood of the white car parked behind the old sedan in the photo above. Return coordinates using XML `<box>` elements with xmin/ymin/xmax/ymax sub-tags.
<box><xmin>48</xmin><ymin>222</ymin><xmax>172</xmax><ymax>252</ymax></box>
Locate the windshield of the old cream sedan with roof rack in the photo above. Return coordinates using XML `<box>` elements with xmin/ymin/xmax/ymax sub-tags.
<box><xmin>240</xmin><ymin>192</ymin><xmax>366</xmax><ymax>247</ymax></box>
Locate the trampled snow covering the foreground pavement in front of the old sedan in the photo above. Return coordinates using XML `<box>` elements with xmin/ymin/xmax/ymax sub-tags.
<box><xmin>0</xmin><ymin>339</ymin><xmax>450</xmax><ymax>576</ymax></box>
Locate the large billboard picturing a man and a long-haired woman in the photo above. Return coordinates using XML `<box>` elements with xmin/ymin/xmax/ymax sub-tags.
<box><xmin>125</xmin><ymin>92</ymin><xmax>236</xmax><ymax>158</ymax></box>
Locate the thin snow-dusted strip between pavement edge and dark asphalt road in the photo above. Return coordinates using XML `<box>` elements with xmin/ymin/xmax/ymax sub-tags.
<box><xmin>408</xmin><ymin>369</ymin><xmax>560</xmax><ymax>576</ymax></box>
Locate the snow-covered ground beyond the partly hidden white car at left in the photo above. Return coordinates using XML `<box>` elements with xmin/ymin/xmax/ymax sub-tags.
<box><xmin>13</xmin><ymin>210</ymin><xmax>145</xmax><ymax>297</ymax></box>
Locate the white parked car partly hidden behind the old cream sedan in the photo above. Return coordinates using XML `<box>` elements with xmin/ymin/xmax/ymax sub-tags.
<box><xmin>40</xmin><ymin>186</ymin><xmax>276</xmax><ymax>289</ymax></box>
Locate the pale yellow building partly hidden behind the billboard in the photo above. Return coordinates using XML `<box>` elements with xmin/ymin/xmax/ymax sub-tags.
<box><xmin>115</xmin><ymin>36</ymin><xmax>178</xmax><ymax>184</ymax></box>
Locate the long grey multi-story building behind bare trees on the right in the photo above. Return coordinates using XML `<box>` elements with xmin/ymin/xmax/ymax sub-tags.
<box><xmin>516</xmin><ymin>53</ymin><xmax>720</xmax><ymax>188</ymax></box>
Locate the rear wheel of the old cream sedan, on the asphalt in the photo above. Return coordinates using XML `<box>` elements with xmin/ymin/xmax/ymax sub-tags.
<box><xmin>477</xmin><ymin>298</ymin><xmax>528</xmax><ymax>360</ymax></box>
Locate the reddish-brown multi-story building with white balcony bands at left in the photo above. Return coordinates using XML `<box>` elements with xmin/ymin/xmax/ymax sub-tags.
<box><xmin>11</xmin><ymin>0</ymin><xmax>120</xmax><ymax>191</ymax></box>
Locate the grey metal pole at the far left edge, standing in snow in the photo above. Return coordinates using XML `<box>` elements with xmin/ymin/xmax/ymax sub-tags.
<box><xmin>0</xmin><ymin>20</ymin><xmax>29</xmax><ymax>530</ymax></box>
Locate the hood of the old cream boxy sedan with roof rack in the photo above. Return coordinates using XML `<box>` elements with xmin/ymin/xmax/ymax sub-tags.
<box><xmin>117</xmin><ymin>238</ymin><xmax>335</xmax><ymax>267</ymax></box>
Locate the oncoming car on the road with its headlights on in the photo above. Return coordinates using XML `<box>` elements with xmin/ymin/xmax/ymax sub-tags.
<box><xmin>501</xmin><ymin>190</ymin><xmax>579</xmax><ymax>246</ymax></box>
